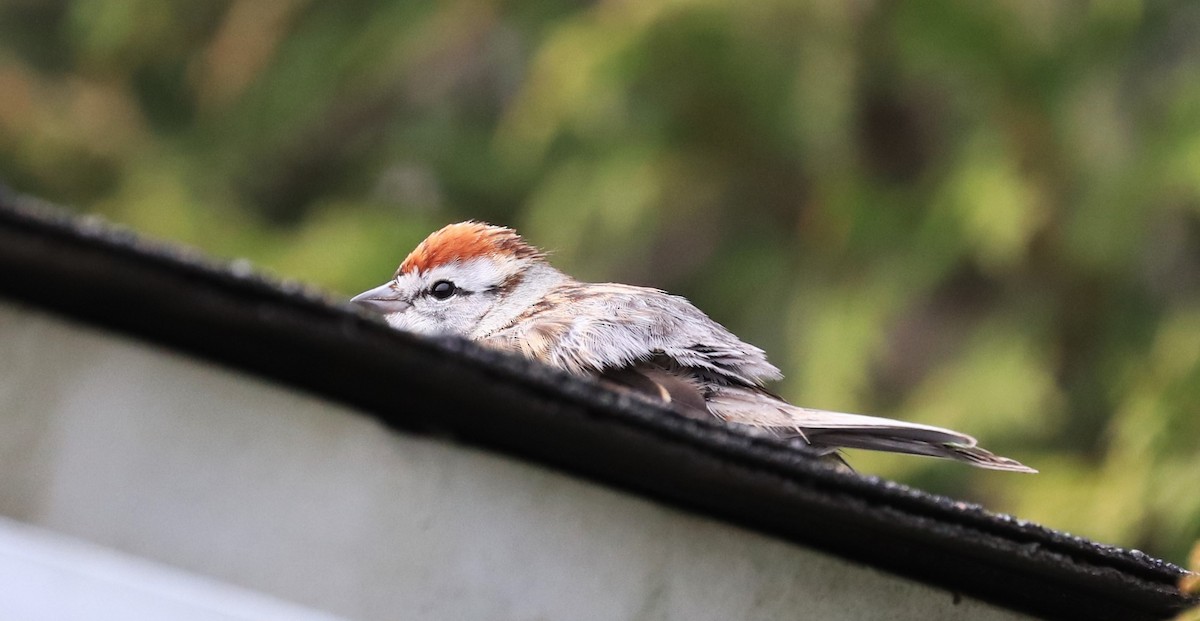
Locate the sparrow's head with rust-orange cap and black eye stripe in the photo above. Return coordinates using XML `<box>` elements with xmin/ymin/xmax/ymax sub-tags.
<box><xmin>352</xmin><ymin>222</ymin><xmax>564</xmax><ymax>338</ymax></box>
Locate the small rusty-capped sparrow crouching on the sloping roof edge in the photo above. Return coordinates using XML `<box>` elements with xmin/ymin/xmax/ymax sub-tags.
<box><xmin>350</xmin><ymin>221</ymin><xmax>1036</xmax><ymax>472</ymax></box>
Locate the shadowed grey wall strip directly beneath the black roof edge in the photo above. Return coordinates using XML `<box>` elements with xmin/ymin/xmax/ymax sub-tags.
<box><xmin>0</xmin><ymin>301</ymin><xmax>1020</xmax><ymax>621</ymax></box>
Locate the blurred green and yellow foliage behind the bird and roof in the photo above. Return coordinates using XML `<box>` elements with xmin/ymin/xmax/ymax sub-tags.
<box><xmin>0</xmin><ymin>0</ymin><xmax>1200</xmax><ymax>561</ymax></box>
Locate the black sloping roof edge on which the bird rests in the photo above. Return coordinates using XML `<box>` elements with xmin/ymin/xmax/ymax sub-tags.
<box><xmin>0</xmin><ymin>193</ymin><xmax>1189</xmax><ymax>620</ymax></box>
